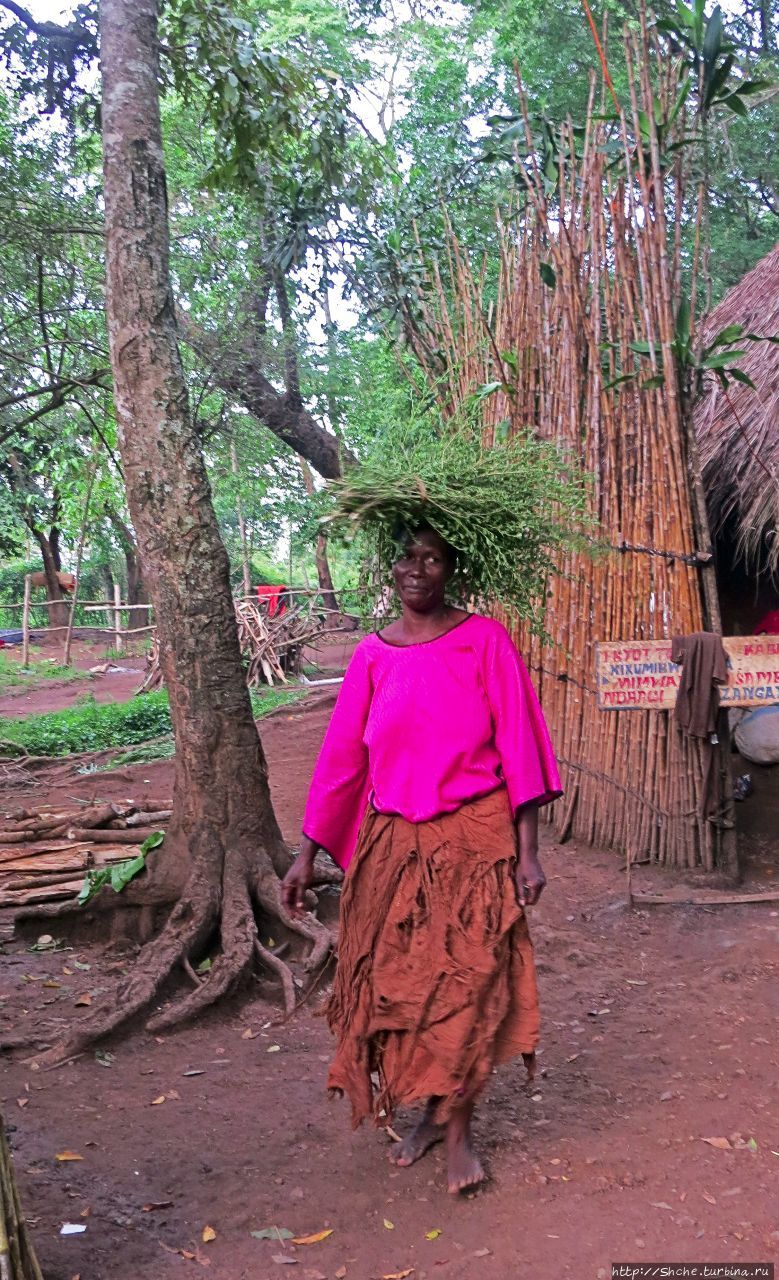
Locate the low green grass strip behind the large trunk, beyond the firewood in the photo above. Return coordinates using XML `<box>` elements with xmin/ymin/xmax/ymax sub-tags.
<box><xmin>0</xmin><ymin>687</ymin><xmax>303</xmax><ymax>764</ymax></box>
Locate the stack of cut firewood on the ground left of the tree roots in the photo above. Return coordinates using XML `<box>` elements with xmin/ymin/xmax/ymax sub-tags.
<box><xmin>0</xmin><ymin>801</ymin><xmax>170</xmax><ymax>906</ymax></box>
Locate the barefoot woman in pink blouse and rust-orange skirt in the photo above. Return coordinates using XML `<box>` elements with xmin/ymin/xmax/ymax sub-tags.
<box><xmin>278</xmin><ymin>525</ymin><xmax>560</xmax><ymax>1193</ymax></box>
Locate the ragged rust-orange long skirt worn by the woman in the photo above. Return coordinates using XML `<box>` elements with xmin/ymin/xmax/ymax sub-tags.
<box><xmin>326</xmin><ymin>788</ymin><xmax>539</xmax><ymax>1126</ymax></box>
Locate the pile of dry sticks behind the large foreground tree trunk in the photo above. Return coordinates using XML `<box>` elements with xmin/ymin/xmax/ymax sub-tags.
<box><xmin>138</xmin><ymin>591</ymin><xmax>344</xmax><ymax>694</ymax></box>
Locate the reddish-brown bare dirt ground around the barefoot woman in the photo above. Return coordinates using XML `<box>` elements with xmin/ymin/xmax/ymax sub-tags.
<box><xmin>0</xmin><ymin>690</ymin><xmax>779</xmax><ymax>1280</ymax></box>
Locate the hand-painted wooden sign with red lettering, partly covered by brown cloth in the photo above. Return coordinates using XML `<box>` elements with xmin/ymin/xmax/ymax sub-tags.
<box><xmin>595</xmin><ymin>636</ymin><xmax>779</xmax><ymax>710</ymax></box>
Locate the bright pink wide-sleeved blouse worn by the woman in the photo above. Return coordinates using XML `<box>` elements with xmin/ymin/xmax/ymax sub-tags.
<box><xmin>303</xmin><ymin>613</ymin><xmax>562</xmax><ymax>867</ymax></box>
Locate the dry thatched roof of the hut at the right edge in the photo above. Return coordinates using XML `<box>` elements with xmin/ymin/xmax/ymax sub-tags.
<box><xmin>695</xmin><ymin>244</ymin><xmax>779</xmax><ymax>572</ymax></box>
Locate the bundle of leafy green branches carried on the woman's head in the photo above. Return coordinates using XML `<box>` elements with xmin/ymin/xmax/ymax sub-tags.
<box><xmin>325</xmin><ymin>428</ymin><xmax>592</xmax><ymax>635</ymax></box>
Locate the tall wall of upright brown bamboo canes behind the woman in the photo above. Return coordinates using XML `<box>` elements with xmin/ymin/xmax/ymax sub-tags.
<box><xmin>414</xmin><ymin>20</ymin><xmax>733</xmax><ymax>870</ymax></box>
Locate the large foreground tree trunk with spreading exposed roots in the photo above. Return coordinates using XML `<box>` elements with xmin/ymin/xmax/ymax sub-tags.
<box><xmin>38</xmin><ymin>0</ymin><xmax>330</xmax><ymax>1056</ymax></box>
